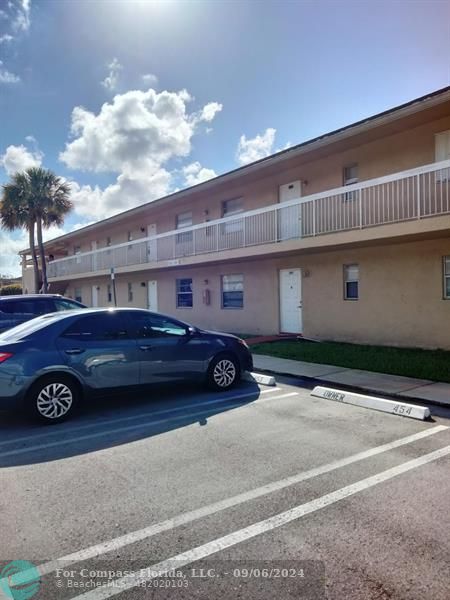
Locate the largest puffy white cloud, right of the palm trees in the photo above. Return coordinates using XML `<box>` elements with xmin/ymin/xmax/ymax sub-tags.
<box><xmin>60</xmin><ymin>89</ymin><xmax>221</xmax><ymax>218</ymax></box>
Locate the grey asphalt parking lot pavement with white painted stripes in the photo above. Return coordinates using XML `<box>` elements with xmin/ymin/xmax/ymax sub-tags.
<box><xmin>0</xmin><ymin>379</ymin><xmax>450</xmax><ymax>600</ymax></box>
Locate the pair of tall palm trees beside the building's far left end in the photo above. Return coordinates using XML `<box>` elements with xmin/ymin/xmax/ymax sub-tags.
<box><xmin>0</xmin><ymin>167</ymin><xmax>72</xmax><ymax>293</ymax></box>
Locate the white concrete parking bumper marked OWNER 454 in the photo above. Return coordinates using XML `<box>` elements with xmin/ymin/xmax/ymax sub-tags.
<box><xmin>311</xmin><ymin>385</ymin><xmax>430</xmax><ymax>421</ymax></box>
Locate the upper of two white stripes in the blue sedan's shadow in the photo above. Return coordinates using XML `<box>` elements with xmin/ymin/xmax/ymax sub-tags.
<box><xmin>0</xmin><ymin>387</ymin><xmax>283</xmax><ymax>447</ymax></box>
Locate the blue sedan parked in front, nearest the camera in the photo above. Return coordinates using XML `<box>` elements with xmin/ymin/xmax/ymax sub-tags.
<box><xmin>0</xmin><ymin>308</ymin><xmax>253</xmax><ymax>423</ymax></box>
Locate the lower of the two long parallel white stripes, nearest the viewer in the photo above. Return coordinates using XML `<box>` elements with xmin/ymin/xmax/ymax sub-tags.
<box><xmin>68</xmin><ymin>446</ymin><xmax>450</xmax><ymax>600</ymax></box>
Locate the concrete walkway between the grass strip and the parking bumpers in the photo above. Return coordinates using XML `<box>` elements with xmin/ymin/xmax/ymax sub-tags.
<box><xmin>253</xmin><ymin>354</ymin><xmax>450</xmax><ymax>406</ymax></box>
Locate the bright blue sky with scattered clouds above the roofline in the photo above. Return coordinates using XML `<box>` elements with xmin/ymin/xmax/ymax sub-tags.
<box><xmin>0</xmin><ymin>0</ymin><xmax>450</xmax><ymax>275</ymax></box>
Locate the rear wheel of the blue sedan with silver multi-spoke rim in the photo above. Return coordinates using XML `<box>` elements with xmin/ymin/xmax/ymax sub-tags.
<box><xmin>27</xmin><ymin>375</ymin><xmax>79</xmax><ymax>424</ymax></box>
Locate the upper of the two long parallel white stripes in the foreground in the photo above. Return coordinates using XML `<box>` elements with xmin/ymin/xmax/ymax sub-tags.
<box><xmin>23</xmin><ymin>425</ymin><xmax>448</xmax><ymax>575</ymax></box>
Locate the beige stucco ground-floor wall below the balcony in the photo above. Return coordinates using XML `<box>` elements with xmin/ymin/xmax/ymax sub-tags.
<box><xmin>67</xmin><ymin>238</ymin><xmax>450</xmax><ymax>349</ymax></box>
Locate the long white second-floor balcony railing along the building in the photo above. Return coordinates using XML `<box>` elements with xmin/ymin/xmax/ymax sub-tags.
<box><xmin>48</xmin><ymin>160</ymin><xmax>450</xmax><ymax>277</ymax></box>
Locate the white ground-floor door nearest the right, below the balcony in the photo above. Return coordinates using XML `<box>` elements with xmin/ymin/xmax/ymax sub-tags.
<box><xmin>280</xmin><ymin>269</ymin><xmax>303</xmax><ymax>333</ymax></box>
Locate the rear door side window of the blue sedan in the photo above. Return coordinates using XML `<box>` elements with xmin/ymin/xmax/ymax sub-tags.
<box><xmin>62</xmin><ymin>312</ymin><xmax>128</xmax><ymax>342</ymax></box>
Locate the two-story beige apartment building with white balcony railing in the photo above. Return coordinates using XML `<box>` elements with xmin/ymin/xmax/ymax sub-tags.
<box><xmin>21</xmin><ymin>88</ymin><xmax>450</xmax><ymax>348</ymax></box>
